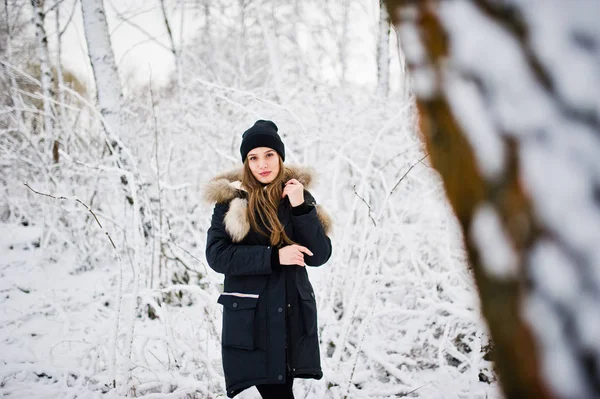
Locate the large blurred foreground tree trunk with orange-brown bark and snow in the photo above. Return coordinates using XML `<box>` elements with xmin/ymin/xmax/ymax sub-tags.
<box><xmin>386</xmin><ymin>0</ymin><xmax>600</xmax><ymax>398</ymax></box>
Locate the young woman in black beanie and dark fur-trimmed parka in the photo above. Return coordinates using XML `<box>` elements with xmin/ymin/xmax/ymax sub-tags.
<box><xmin>205</xmin><ymin>120</ymin><xmax>331</xmax><ymax>399</ymax></box>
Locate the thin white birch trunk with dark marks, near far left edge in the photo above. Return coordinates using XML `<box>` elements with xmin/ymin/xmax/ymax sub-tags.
<box><xmin>31</xmin><ymin>0</ymin><xmax>54</xmax><ymax>137</ymax></box>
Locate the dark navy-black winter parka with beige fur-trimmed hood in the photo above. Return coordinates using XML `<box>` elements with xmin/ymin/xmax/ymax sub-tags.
<box><xmin>205</xmin><ymin>165</ymin><xmax>332</xmax><ymax>398</ymax></box>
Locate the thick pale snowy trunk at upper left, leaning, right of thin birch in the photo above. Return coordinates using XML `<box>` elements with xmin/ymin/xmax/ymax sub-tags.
<box><xmin>81</xmin><ymin>0</ymin><xmax>123</xmax><ymax>142</ymax></box>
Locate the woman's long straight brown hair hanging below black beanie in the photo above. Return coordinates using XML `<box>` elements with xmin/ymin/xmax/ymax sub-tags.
<box><xmin>242</xmin><ymin>157</ymin><xmax>296</xmax><ymax>246</ymax></box>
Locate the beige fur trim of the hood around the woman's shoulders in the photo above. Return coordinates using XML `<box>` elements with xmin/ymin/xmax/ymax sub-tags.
<box><xmin>203</xmin><ymin>165</ymin><xmax>332</xmax><ymax>242</ymax></box>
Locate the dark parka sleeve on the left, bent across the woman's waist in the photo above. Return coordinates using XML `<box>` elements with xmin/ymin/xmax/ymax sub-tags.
<box><xmin>206</xmin><ymin>203</ymin><xmax>278</xmax><ymax>276</ymax></box>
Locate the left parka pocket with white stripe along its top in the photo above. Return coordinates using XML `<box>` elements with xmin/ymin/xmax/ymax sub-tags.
<box><xmin>217</xmin><ymin>292</ymin><xmax>258</xmax><ymax>350</ymax></box>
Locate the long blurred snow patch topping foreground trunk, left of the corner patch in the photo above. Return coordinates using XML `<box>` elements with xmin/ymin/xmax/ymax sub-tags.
<box><xmin>439</xmin><ymin>1</ymin><xmax>556</xmax><ymax>135</ymax></box>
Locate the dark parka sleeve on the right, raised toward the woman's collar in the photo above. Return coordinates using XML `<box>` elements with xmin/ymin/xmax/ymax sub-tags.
<box><xmin>292</xmin><ymin>190</ymin><xmax>332</xmax><ymax>266</ymax></box>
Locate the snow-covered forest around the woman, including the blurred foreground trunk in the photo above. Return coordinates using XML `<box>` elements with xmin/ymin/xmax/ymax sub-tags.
<box><xmin>0</xmin><ymin>0</ymin><xmax>600</xmax><ymax>399</ymax></box>
